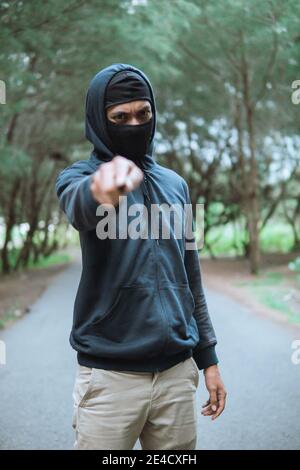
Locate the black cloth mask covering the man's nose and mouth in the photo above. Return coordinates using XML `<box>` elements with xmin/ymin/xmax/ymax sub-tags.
<box><xmin>107</xmin><ymin>117</ymin><xmax>153</xmax><ymax>161</ymax></box>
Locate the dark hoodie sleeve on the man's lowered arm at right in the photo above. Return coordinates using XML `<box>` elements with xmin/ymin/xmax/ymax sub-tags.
<box><xmin>184</xmin><ymin>181</ymin><xmax>219</xmax><ymax>369</ymax></box>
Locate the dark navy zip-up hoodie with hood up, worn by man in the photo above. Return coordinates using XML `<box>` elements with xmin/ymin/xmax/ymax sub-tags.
<box><xmin>56</xmin><ymin>63</ymin><xmax>218</xmax><ymax>372</ymax></box>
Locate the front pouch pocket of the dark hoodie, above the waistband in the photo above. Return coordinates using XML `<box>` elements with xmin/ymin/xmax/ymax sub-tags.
<box><xmin>89</xmin><ymin>286</ymin><xmax>168</xmax><ymax>358</ymax></box>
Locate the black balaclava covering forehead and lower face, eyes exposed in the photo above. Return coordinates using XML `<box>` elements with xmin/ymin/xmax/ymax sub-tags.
<box><xmin>105</xmin><ymin>70</ymin><xmax>153</xmax><ymax>161</ymax></box>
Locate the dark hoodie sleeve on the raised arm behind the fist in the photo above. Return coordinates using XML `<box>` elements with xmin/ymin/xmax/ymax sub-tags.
<box><xmin>55</xmin><ymin>160</ymin><xmax>99</xmax><ymax>231</ymax></box>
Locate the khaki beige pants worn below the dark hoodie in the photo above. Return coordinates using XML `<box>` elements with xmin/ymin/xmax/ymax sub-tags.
<box><xmin>72</xmin><ymin>357</ymin><xmax>200</xmax><ymax>450</ymax></box>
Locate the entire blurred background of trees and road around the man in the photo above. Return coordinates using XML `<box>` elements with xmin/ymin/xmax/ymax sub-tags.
<box><xmin>0</xmin><ymin>0</ymin><xmax>300</xmax><ymax>449</ymax></box>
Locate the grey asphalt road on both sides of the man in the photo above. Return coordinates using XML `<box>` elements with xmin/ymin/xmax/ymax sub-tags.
<box><xmin>0</xmin><ymin>255</ymin><xmax>300</xmax><ymax>449</ymax></box>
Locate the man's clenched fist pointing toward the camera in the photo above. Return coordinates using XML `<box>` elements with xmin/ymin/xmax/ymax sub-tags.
<box><xmin>91</xmin><ymin>155</ymin><xmax>143</xmax><ymax>206</ymax></box>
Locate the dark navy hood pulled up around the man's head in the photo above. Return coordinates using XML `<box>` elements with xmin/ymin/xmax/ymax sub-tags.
<box><xmin>85</xmin><ymin>63</ymin><xmax>156</xmax><ymax>166</ymax></box>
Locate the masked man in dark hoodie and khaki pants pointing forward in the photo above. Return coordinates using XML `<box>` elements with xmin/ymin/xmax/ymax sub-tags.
<box><xmin>56</xmin><ymin>64</ymin><xmax>226</xmax><ymax>449</ymax></box>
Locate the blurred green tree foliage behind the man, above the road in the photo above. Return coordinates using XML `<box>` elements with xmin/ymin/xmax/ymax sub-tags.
<box><xmin>0</xmin><ymin>0</ymin><xmax>300</xmax><ymax>272</ymax></box>
